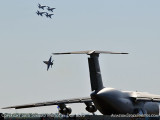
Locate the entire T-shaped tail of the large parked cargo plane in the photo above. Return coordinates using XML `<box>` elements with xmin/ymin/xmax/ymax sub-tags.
<box><xmin>53</xmin><ymin>50</ymin><xmax>128</xmax><ymax>92</ymax></box>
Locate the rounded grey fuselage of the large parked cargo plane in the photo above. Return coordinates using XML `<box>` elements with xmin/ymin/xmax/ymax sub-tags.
<box><xmin>91</xmin><ymin>88</ymin><xmax>159</xmax><ymax>115</ymax></box>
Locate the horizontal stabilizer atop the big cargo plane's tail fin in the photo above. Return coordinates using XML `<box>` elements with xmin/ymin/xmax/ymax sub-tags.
<box><xmin>53</xmin><ymin>50</ymin><xmax>128</xmax><ymax>55</ymax></box>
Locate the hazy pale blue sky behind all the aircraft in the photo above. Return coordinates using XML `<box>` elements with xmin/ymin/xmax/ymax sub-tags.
<box><xmin>0</xmin><ymin>0</ymin><xmax>160</xmax><ymax>114</ymax></box>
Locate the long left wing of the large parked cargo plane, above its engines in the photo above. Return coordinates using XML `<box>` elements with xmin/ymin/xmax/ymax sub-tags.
<box><xmin>2</xmin><ymin>97</ymin><xmax>92</xmax><ymax>109</ymax></box>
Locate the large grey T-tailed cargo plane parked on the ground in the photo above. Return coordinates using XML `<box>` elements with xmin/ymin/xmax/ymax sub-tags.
<box><xmin>3</xmin><ymin>50</ymin><xmax>160</xmax><ymax>115</ymax></box>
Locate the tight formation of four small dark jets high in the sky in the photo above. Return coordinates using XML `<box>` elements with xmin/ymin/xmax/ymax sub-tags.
<box><xmin>36</xmin><ymin>3</ymin><xmax>56</xmax><ymax>18</ymax></box>
